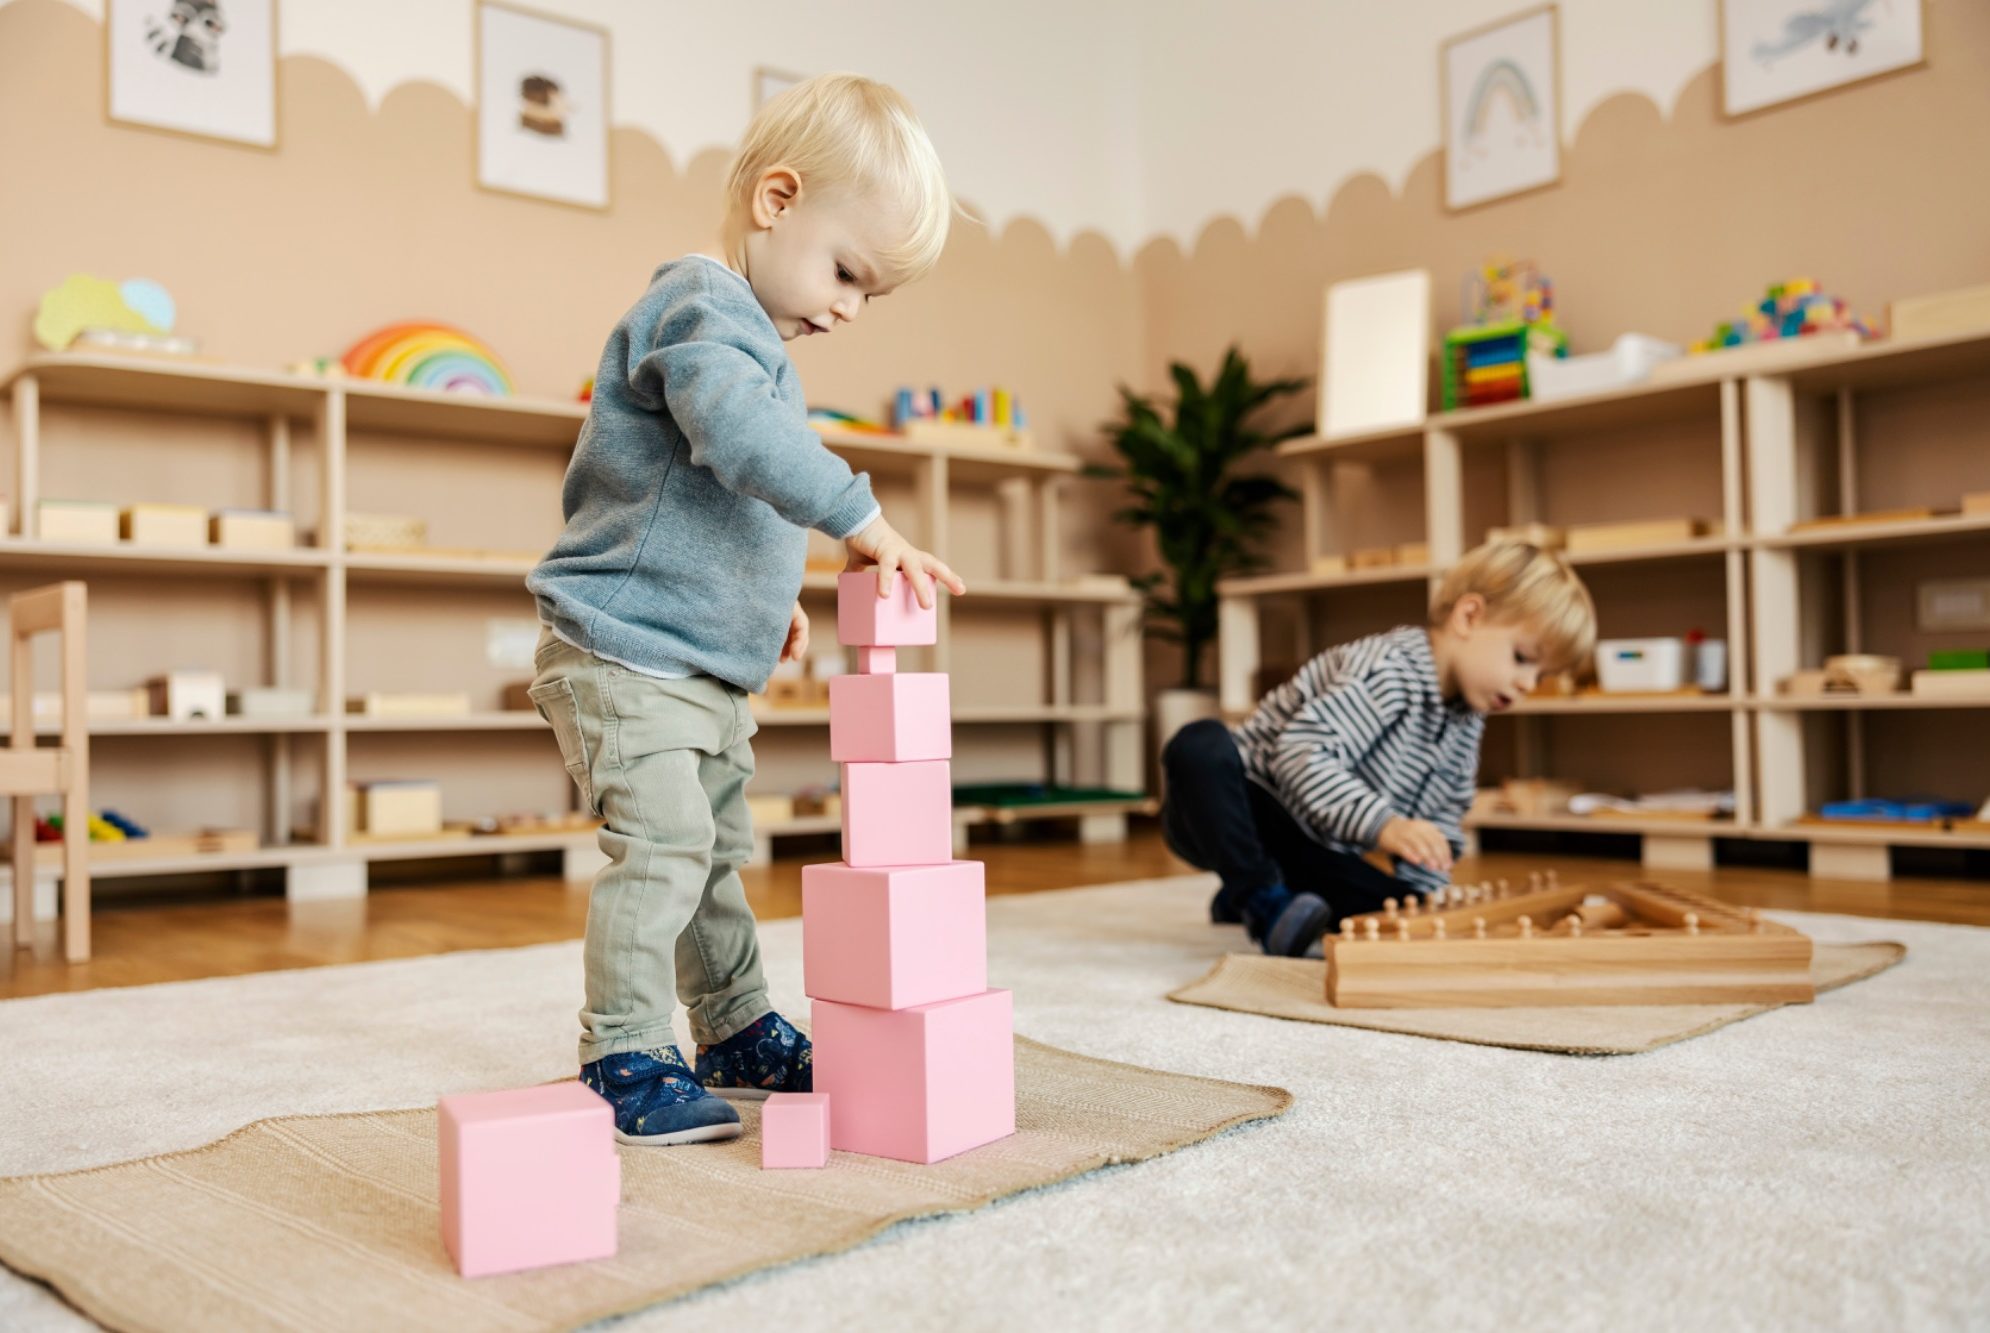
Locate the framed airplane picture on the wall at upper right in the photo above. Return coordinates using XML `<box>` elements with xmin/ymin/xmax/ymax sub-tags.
<box><xmin>1721</xmin><ymin>0</ymin><xmax>1928</xmax><ymax>115</ymax></box>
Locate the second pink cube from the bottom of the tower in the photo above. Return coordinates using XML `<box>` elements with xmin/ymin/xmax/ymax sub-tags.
<box><xmin>802</xmin><ymin>861</ymin><xmax>989</xmax><ymax>1009</ymax></box>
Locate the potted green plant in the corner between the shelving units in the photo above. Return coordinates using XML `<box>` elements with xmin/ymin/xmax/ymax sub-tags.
<box><xmin>1087</xmin><ymin>346</ymin><xmax>1311</xmax><ymax>744</ymax></box>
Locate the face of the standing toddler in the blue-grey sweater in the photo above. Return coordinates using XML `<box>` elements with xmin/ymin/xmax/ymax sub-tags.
<box><xmin>746</xmin><ymin>193</ymin><xmax>892</xmax><ymax>342</ymax></box>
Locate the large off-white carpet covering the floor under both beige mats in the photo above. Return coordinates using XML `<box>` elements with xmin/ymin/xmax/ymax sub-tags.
<box><xmin>0</xmin><ymin>877</ymin><xmax>1990</xmax><ymax>1333</ymax></box>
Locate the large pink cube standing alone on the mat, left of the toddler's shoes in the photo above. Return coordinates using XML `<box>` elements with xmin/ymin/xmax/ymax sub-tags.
<box><xmin>436</xmin><ymin>1082</ymin><xmax>621</xmax><ymax>1277</ymax></box>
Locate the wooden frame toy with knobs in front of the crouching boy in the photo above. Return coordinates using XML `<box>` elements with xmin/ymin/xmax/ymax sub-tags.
<box><xmin>1323</xmin><ymin>871</ymin><xmax>1815</xmax><ymax>1009</ymax></box>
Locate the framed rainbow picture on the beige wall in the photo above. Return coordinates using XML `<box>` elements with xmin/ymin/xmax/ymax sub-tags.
<box><xmin>1437</xmin><ymin>4</ymin><xmax>1562</xmax><ymax>209</ymax></box>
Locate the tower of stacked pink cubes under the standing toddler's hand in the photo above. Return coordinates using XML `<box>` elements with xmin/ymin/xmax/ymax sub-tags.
<box><xmin>802</xmin><ymin>571</ymin><xmax>1015</xmax><ymax>1162</ymax></box>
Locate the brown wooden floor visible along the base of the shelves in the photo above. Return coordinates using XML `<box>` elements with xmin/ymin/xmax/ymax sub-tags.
<box><xmin>0</xmin><ymin>832</ymin><xmax>1990</xmax><ymax>999</ymax></box>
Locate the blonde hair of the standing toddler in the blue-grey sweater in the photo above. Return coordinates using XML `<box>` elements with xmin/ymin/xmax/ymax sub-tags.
<box><xmin>726</xmin><ymin>74</ymin><xmax>953</xmax><ymax>286</ymax></box>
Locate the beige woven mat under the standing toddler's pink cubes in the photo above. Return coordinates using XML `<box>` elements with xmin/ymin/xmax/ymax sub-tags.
<box><xmin>0</xmin><ymin>1039</ymin><xmax>1292</xmax><ymax>1333</ymax></box>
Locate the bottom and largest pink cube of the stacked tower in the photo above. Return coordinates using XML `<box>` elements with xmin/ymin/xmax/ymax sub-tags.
<box><xmin>812</xmin><ymin>991</ymin><xmax>1015</xmax><ymax>1162</ymax></box>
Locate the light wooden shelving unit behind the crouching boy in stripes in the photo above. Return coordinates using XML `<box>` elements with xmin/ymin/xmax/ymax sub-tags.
<box><xmin>1222</xmin><ymin>334</ymin><xmax>1990</xmax><ymax>879</ymax></box>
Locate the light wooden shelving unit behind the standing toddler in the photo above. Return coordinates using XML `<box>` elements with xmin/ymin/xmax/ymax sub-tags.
<box><xmin>0</xmin><ymin>354</ymin><xmax>1144</xmax><ymax>897</ymax></box>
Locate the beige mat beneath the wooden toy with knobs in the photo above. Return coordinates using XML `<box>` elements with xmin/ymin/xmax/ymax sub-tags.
<box><xmin>1168</xmin><ymin>941</ymin><xmax>1906</xmax><ymax>1054</ymax></box>
